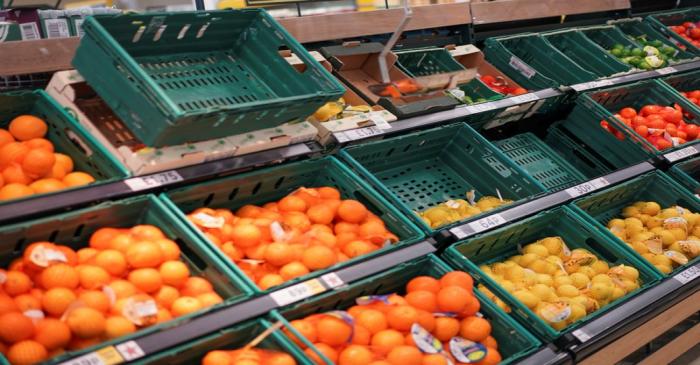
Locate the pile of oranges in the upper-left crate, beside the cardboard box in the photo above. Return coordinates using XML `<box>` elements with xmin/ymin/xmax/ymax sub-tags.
<box><xmin>0</xmin><ymin>115</ymin><xmax>95</xmax><ymax>201</ymax></box>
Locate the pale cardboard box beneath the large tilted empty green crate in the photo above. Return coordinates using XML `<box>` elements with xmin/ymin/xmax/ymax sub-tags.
<box><xmin>47</xmin><ymin>70</ymin><xmax>318</xmax><ymax>175</ymax></box>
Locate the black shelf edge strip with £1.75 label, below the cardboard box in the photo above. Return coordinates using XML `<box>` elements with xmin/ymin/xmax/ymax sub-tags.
<box><xmin>0</xmin><ymin>143</ymin><xmax>314</xmax><ymax>225</ymax></box>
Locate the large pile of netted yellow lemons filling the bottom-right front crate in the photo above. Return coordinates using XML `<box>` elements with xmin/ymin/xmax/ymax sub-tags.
<box><xmin>479</xmin><ymin>237</ymin><xmax>639</xmax><ymax>330</ymax></box>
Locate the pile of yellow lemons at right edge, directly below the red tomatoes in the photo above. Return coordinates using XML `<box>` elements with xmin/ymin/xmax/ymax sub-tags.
<box><xmin>608</xmin><ymin>201</ymin><xmax>700</xmax><ymax>274</ymax></box>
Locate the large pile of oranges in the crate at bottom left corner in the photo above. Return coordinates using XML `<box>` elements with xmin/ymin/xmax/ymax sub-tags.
<box><xmin>0</xmin><ymin>225</ymin><xmax>222</xmax><ymax>365</ymax></box>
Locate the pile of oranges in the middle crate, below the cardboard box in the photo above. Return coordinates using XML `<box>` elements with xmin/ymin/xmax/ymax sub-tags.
<box><xmin>187</xmin><ymin>186</ymin><xmax>398</xmax><ymax>290</ymax></box>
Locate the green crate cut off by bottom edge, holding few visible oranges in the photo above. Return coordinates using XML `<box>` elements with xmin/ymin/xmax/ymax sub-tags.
<box><xmin>135</xmin><ymin>318</ymin><xmax>314</xmax><ymax>365</ymax></box>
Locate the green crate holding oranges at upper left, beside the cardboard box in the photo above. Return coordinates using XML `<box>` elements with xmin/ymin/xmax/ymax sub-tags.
<box><xmin>0</xmin><ymin>90</ymin><xmax>129</xmax><ymax>204</ymax></box>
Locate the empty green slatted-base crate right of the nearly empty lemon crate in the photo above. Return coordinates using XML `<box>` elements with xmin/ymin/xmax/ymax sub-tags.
<box><xmin>484</xmin><ymin>133</ymin><xmax>586</xmax><ymax>191</ymax></box>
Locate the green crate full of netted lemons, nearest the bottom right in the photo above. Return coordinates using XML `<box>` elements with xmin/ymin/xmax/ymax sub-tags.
<box><xmin>443</xmin><ymin>206</ymin><xmax>660</xmax><ymax>341</ymax></box>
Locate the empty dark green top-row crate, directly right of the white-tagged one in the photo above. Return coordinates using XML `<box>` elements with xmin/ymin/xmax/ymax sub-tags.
<box><xmin>542</xmin><ymin>29</ymin><xmax>632</xmax><ymax>77</ymax></box>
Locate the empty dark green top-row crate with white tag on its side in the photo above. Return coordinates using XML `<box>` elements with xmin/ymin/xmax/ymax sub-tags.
<box><xmin>484</xmin><ymin>33</ymin><xmax>598</xmax><ymax>90</ymax></box>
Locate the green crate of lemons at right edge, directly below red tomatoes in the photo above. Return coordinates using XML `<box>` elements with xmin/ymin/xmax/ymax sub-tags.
<box><xmin>572</xmin><ymin>171</ymin><xmax>700</xmax><ymax>275</ymax></box>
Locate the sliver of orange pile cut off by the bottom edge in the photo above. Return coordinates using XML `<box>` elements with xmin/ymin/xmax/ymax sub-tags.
<box><xmin>202</xmin><ymin>349</ymin><xmax>297</xmax><ymax>365</ymax></box>
